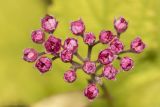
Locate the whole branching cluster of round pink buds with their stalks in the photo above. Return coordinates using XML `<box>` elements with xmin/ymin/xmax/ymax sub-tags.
<box><xmin>23</xmin><ymin>15</ymin><xmax>145</xmax><ymax>100</ymax></box>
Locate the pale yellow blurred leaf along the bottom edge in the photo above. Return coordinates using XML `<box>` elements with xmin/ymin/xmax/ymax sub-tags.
<box><xmin>32</xmin><ymin>91</ymin><xmax>87</xmax><ymax>107</ymax></box>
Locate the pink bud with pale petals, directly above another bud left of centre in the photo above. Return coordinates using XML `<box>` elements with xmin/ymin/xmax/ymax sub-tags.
<box><xmin>63</xmin><ymin>38</ymin><xmax>78</xmax><ymax>53</ymax></box>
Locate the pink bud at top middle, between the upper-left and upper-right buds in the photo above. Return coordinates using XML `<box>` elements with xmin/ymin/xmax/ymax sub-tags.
<box><xmin>71</xmin><ymin>19</ymin><xmax>85</xmax><ymax>35</ymax></box>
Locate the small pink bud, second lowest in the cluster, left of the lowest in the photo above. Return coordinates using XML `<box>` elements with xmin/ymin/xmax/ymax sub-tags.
<box><xmin>64</xmin><ymin>70</ymin><xmax>77</xmax><ymax>83</ymax></box>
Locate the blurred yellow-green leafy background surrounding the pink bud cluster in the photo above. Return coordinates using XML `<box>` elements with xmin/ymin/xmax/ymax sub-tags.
<box><xmin>0</xmin><ymin>0</ymin><xmax>160</xmax><ymax>107</ymax></box>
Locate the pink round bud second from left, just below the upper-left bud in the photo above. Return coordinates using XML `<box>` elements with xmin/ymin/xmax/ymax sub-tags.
<box><xmin>31</xmin><ymin>29</ymin><xmax>45</xmax><ymax>44</ymax></box>
